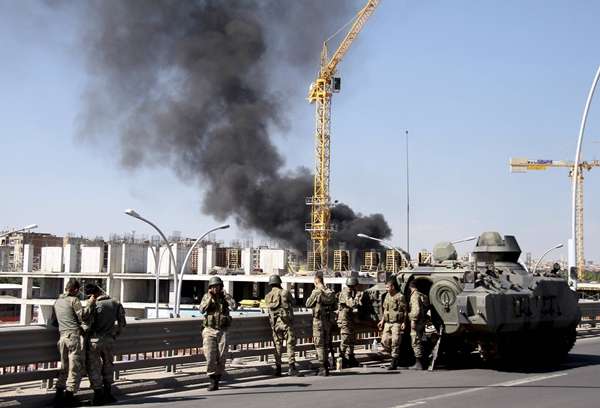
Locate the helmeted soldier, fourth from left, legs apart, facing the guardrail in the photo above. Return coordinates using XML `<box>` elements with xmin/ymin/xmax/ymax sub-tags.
<box><xmin>265</xmin><ymin>275</ymin><xmax>302</xmax><ymax>377</ymax></box>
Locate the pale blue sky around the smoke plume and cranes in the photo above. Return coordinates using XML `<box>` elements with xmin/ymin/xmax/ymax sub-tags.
<box><xmin>0</xmin><ymin>0</ymin><xmax>600</xmax><ymax>260</ymax></box>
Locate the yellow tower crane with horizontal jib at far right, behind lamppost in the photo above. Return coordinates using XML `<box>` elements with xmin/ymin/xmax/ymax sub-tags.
<box><xmin>510</xmin><ymin>158</ymin><xmax>600</xmax><ymax>280</ymax></box>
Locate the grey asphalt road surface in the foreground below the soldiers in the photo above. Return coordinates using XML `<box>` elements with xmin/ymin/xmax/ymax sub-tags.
<box><xmin>119</xmin><ymin>338</ymin><xmax>600</xmax><ymax>408</ymax></box>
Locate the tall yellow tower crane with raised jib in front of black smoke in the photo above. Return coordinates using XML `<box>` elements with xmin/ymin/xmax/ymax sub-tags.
<box><xmin>306</xmin><ymin>0</ymin><xmax>379</xmax><ymax>270</ymax></box>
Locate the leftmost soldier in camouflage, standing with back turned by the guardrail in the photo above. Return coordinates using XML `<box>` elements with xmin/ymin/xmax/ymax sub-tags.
<box><xmin>50</xmin><ymin>279</ymin><xmax>94</xmax><ymax>407</ymax></box>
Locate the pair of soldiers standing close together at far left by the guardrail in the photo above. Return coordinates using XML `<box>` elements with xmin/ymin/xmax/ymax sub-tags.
<box><xmin>50</xmin><ymin>279</ymin><xmax>126</xmax><ymax>408</ymax></box>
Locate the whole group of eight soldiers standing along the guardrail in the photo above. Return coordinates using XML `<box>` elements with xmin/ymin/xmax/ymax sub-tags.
<box><xmin>52</xmin><ymin>273</ymin><xmax>429</xmax><ymax>407</ymax></box>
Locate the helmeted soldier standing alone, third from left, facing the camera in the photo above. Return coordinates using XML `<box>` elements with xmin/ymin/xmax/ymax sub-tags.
<box><xmin>200</xmin><ymin>276</ymin><xmax>237</xmax><ymax>391</ymax></box>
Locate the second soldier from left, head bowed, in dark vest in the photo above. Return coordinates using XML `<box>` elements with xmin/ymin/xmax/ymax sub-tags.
<box><xmin>84</xmin><ymin>284</ymin><xmax>126</xmax><ymax>405</ymax></box>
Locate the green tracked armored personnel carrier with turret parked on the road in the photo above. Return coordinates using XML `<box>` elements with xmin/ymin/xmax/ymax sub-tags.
<box><xmin>360</xmin><ymin>232</ymin><xmax>581</xmax><ymax>362</ymax></box>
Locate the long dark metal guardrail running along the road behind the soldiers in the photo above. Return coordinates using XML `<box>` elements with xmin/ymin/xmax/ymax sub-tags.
<box><xmin>0</xmin><ymin>301</ymin><xmax>600</xmax><ymax>385</ymax></box>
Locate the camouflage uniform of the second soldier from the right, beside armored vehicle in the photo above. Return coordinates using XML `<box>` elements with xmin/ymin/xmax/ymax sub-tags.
<box><xmin>381</xmin><ymin>292</ymin><xmax>406</xmax><ymax>359</ymax></box>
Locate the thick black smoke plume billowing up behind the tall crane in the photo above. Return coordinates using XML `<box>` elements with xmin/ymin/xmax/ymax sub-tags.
<box><xmin>79</xmin><ymin>0</ymin><xmax>391</xmax><ymax>250</ymax></box>
